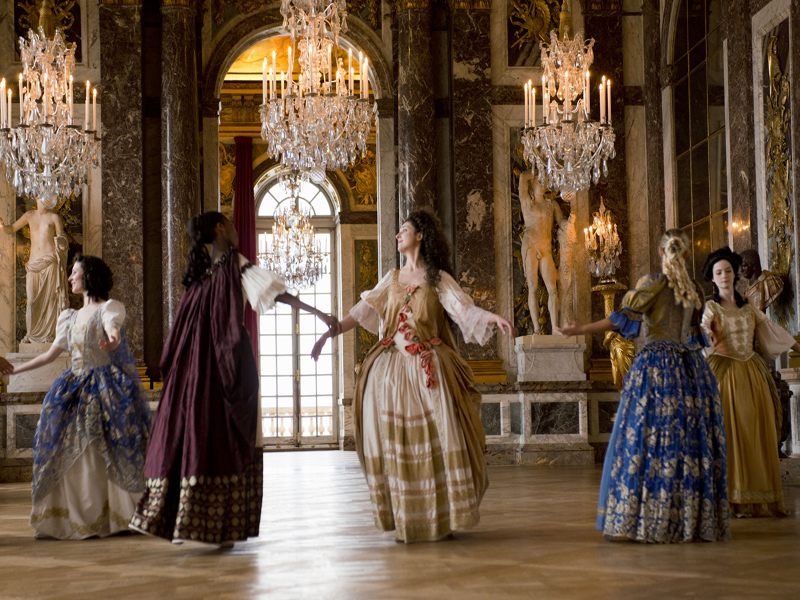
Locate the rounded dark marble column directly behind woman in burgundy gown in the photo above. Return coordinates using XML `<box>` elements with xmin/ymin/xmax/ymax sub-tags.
<box><xmin>161</xmin><ymin>0</ymin><xmax>200</xmax><ymax>339</ymax></box>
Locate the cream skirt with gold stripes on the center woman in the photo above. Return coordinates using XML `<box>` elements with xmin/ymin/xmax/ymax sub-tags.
<box><xmin>362</xmin><ymin>346</ymin><xmax>486</xmax><ymax>543</ymax></box>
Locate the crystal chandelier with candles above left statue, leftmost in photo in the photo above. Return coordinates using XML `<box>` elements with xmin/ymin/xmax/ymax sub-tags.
<box><xmin>0</xmin><ymin>27</ymin><xmax>100</xmax><ymax>208</ymax></box>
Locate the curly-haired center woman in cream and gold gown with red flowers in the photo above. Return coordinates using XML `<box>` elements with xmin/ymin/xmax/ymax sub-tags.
<box><xmin>312</xmin><ymin>211</ymin><xmax>515</xmax><ymax>542</ymax></box>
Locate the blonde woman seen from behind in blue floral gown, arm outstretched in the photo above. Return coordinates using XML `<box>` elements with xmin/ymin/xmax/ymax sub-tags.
<box><xmin>559</xmin><ymin>229</ymin><xmax>730</xmax><ymax>543</ymax></box>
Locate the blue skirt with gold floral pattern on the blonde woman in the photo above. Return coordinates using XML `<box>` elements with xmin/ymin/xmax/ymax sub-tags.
<box><xmin>597</xmin><ymin>341</ymin><xmax>730</xmax><ymax>543</ymax></box>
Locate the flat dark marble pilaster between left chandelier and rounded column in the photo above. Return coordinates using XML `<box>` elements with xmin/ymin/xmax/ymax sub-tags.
<box><xmin>99</xmin><ymin>0</ymin><xmax>144</xmax><ymax>364</ymax></box>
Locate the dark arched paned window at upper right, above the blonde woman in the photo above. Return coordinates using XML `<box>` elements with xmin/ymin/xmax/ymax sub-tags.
<box><xmin>672</xmin><ymin>0</ymin><xmax>728</xmax><ymax>293</ymax></box>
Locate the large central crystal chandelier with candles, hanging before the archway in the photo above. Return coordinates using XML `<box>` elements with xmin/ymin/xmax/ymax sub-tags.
<box><xmin>260</xmin><ymin>0</ymin><xmax>377</xmax><ymax>174</ymax></box>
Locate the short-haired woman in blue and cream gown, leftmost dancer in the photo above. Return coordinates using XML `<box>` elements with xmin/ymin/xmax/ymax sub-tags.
<box><xmin>1</xmin><ymin>255</ymin><xmax>151</xmax><ymax>540</ymax></box>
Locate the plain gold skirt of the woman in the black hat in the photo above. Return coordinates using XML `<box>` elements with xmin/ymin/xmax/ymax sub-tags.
<box><xmin>708</xmin><ymin>354</ymin><xmax>788</xmax><ymax>517</ymax></box>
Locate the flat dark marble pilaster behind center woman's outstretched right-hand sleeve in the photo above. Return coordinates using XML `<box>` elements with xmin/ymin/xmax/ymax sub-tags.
<box><xmin>451</xmin><ymin>0</ymin><xmax>494</xmax><ymax>360</ymax></box>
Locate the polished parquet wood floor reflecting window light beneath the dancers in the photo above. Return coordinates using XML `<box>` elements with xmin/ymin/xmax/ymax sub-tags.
<box><xmin>0</xmin><ymin>452</ymin><xmax>800</xmax><ymax>600</ymax></box>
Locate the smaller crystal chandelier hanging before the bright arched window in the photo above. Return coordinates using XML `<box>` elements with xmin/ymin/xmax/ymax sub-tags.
<box><xmin>259</xmin><ymin>170</ymin><xmax>328</xmax><ymax>290</ymax></box>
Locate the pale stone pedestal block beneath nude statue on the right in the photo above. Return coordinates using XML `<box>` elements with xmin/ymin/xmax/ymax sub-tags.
<box><xmin>514</xmin><ymin>335</ymin><xmax>586</xmax><ymax>381</ymax></box>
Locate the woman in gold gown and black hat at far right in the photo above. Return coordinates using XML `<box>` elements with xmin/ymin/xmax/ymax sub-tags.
<box><xmin>702</xmin><ymin>246</ymin><xmax>800</xmax><ymax>517</ymax></box>
